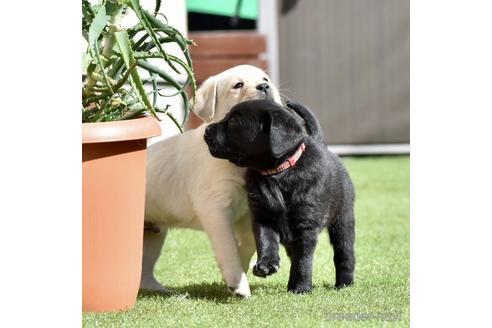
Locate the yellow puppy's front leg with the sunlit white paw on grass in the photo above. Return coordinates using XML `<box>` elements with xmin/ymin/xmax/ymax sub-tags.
<box><xmin>198</xmin><ymin>205</ymin><xmax>251</xmax><ymax>297</ymax></box>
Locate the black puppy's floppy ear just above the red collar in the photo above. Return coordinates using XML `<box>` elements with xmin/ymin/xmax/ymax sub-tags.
<box><xmin>269</xmin><ymin>111</ymin><xmax>303</xmax><ymax>158</ymax></box>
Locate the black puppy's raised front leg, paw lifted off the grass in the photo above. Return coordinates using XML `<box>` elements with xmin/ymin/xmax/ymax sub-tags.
<box><xmin>253</xmin><ymin>220</ymin><xmax>280</xmax><ymax>277</ymax></box>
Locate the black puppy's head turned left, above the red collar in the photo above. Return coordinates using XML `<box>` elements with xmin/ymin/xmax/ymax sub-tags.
<box><xmin>204</xmin><ymin>100</ymin><xmax>304</xmax><ymax>170</ymax></box>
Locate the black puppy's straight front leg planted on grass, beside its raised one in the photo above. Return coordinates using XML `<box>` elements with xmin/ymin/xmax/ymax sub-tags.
<box><xmin>287</xmin><ymin>230</ymin><xmax>318</xmax><ymax>294</ymax></box>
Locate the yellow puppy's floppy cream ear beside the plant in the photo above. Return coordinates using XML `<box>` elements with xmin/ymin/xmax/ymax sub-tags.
<box><xmin>192</xmin><ymin>76</ymin><xmax>218</xmax><ymax>123</ymax></box>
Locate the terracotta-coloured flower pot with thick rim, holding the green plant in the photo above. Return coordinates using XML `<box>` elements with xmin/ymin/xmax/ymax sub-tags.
<box><xmin>82</xmin><ymin>117</ymin><xmax>161</xmax><ymax>311</ymax></box>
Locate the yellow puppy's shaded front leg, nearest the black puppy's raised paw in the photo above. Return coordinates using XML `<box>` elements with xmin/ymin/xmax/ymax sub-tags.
<box><xmin>234</xmin><ymin>213</ymin><xmax>256</xmax><ymax>273</ymax></box>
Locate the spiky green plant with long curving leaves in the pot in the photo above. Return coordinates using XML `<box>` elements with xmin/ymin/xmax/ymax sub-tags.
<box><xmin>82</xmin><ymin>0</ymin><xmax>196</xmax><ymax>130</ymax></box>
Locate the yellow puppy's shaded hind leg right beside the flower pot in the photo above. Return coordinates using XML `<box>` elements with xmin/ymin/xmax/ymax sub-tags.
<box><xmin>140</xmin><ymin>228</ymin><xmax>170</xmax><ymax>293</ymax></box>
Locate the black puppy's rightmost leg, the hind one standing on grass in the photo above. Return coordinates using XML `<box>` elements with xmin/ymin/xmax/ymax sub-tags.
<box><xmin>328</xmin><ymin>208</ymin><xmax>355</xmax><ymax>288</ymax></box>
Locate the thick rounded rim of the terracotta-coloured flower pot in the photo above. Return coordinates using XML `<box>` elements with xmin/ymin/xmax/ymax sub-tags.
<box><xmin>82</xmin><ymin>116</ymin><xmax>162</xmax><ymax>144</ymax></box>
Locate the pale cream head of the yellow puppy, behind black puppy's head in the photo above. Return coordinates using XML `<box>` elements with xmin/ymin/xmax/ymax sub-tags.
<box><xmin>193</xmin><ymin>65</ymin><xmax>282</xmax><ymax>122</ymax></box>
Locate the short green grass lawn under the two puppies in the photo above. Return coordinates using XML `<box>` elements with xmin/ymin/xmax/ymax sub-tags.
<box><xmin>83</xmin><ymin>156</ymin><xmax>410</xmax><ymax>327</ymax></box>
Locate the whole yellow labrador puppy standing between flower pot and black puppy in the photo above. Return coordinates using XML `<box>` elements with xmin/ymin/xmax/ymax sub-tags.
<box><xmin>140</xmin><ymin>65</ymin><xmax>281</xmax><ymax>297</ymax></box>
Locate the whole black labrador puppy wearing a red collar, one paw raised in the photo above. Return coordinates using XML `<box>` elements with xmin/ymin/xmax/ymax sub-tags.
<box><xmin>204</xmin><ymin>100</ymin><xmax>355</xmax><ymax>293</ymax></box>
